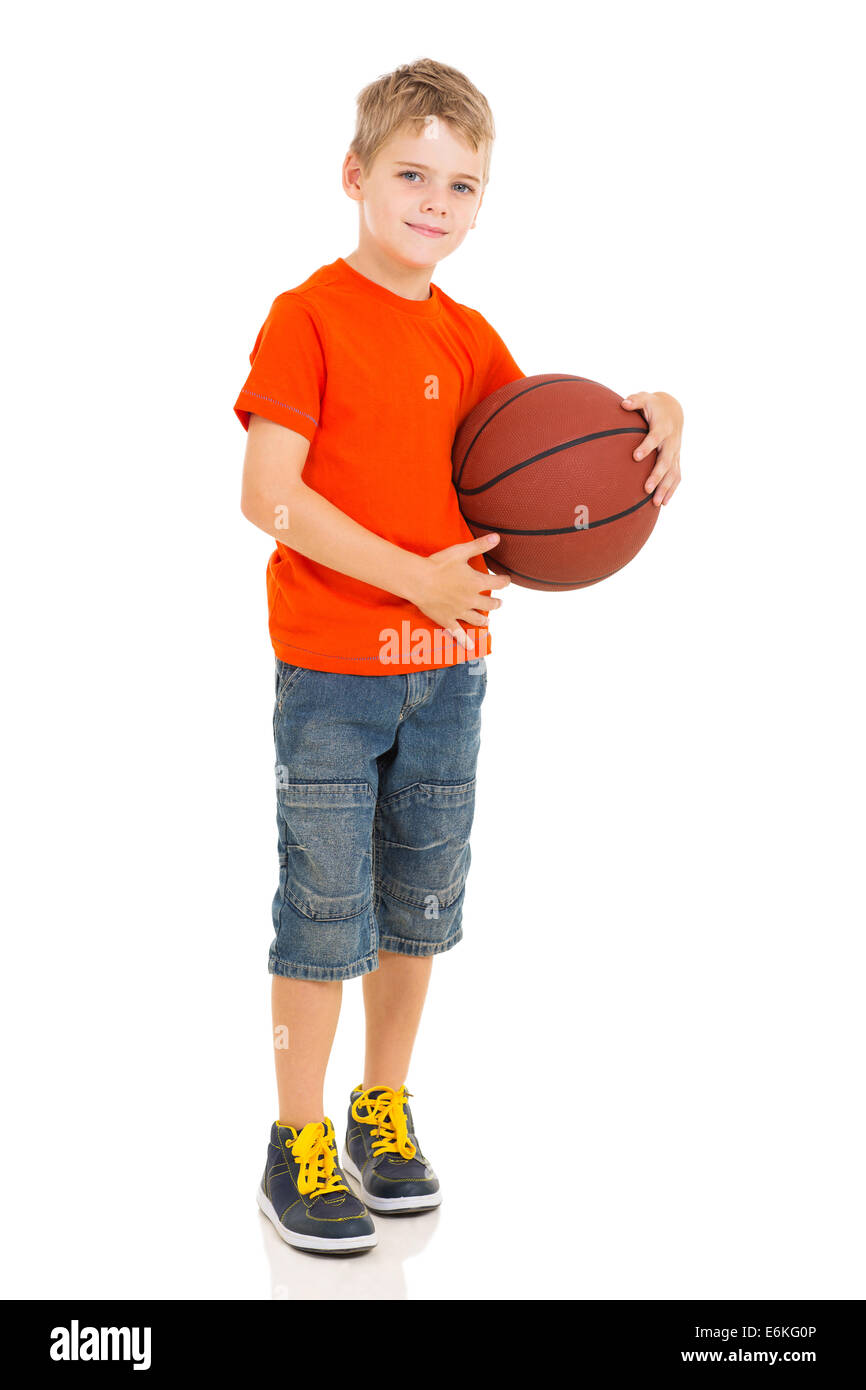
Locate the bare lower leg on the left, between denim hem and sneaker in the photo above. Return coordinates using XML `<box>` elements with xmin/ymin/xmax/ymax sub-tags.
<box><xmin>271</xmin><ymin>974</ymin><xmax>343</xmax><ymax>1130</ymax></box>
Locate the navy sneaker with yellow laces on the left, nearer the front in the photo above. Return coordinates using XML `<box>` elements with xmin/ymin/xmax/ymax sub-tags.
<box><xmin>256</xmin><ymin>1116</ymin><xmax>378</xmax><ymax>1254</ymax></box>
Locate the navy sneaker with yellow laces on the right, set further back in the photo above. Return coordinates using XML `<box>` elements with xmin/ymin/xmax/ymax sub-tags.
<box><xmin>343</xmin><ymin>1086</ymin><xmax>442</xmax><ymax>1212</ymax></box>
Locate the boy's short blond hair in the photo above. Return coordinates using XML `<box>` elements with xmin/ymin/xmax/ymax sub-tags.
<box><xmin>349</xmin><ymin>58</ymin><xmax>496</xmax><ymax>186</ymax></box>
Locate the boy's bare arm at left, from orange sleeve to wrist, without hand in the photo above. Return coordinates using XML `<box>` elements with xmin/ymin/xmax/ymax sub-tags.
<box><xmin>240</xmin><ymin>414</ymin><xmax>428</xmax><ymax>603</ymax></box>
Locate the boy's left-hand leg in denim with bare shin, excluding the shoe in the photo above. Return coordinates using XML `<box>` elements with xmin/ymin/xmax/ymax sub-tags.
<box><xmin>268</xmin><ymin>660</ymin><xmax>408</xmax><ymax>1129</ymax></box>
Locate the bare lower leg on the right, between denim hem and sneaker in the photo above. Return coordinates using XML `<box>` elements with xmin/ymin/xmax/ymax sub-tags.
<box><xmin>364</xmin><ymin>949</ymin><xmax>432</xmax><ymax>1091</ymax></box>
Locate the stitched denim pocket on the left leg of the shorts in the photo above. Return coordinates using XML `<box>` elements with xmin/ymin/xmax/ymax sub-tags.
<box><xmin>277</xmin><ymin>781</ymin><xmax>375</xmax><ymax>922</ymax></box>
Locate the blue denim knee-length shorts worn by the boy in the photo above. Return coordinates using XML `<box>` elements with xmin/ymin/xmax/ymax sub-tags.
<box><xmin>268</xmin><ymin>656</ymin><xmax>487</xmax><ymax>980</ymax></box>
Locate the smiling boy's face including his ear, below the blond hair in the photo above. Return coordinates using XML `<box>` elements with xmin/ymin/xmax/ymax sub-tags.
<box><xmin>343</xmin><ymin>117</ymin><xmax>484</xmax><ymax>267</ymax></box>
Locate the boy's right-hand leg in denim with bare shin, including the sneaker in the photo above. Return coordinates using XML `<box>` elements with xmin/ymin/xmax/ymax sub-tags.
<box><xmin>345</xmin><ymin>657</ymin><xmax>487</xmax><ymax>1212</ymax></box>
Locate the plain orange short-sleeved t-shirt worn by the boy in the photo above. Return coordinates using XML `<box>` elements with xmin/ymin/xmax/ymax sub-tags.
<box><xmin>235</xmin><ymin>256</ymin><xmax>524</xmax><ymax>676</ymax></box>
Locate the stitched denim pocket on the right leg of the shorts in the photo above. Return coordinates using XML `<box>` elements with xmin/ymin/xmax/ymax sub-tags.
<box><xmin>374</xmin><ymin>777</ymin><xmax>475</xmax><ymax>909</ymax></box>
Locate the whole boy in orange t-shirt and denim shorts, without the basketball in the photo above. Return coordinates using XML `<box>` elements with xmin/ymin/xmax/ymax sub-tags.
<box><xmin>235</xmin><ymin>60</ymin><xmax>681</xmax><ymax>1252</ymax></box>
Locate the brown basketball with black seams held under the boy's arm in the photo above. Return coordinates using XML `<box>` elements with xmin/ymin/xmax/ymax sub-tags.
<box><xmin>452</xmin><ymin>373</ymin><xmax>659</xmax><ymax>589</ymax></box>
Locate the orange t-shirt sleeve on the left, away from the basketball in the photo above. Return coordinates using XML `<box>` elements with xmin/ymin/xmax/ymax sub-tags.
<box><xmin>235</xmin><ymin>291</ymin><xmax>325</xmax><ymax>439</ymax></box>
